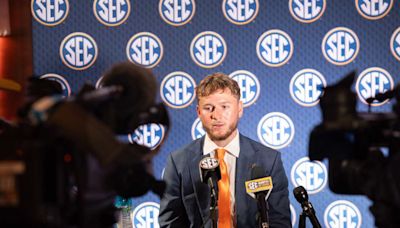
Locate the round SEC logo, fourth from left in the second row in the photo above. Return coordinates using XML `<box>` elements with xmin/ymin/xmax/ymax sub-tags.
<box><xmin>257</xmin><ymin>29</ymin><xmax>294</xmax><ymax>67</ymax></box>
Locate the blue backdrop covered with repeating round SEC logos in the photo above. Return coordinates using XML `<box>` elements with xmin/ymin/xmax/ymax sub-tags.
<box><xmin>32</xmin><ymin>0</ymin><xmax>400</xmax><ymax>227</ymax></box>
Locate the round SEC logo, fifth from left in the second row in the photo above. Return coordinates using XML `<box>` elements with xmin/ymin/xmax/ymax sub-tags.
<box><xmin>322</xmin><ymin>27</ymin><xmax>360</xmax><ymax>66</ymax></box>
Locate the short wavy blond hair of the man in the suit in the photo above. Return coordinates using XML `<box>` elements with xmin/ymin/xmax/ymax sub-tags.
<box><xmin>196</xmin><ymin>72</ymin><xmax>240</xmax><ymax>101</ymax></box>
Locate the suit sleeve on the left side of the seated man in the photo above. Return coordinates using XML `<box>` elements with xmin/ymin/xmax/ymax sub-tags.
<box><xmin>158</xmin><ymin>154</ymin><xmax>189</xmax><ymax>228</ymax></box>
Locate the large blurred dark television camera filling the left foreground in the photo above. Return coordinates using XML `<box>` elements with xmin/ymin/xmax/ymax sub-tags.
<box><xmin>0</xmin><ymin>62</ymin><xmax>169</xmax><ymax>227</ymax></box>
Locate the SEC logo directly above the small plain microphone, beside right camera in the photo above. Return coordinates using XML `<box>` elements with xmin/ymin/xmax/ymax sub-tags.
<box><xmin>290</xmin><ymin>157</ymin><xmax>328</xmax><ymax>194</ymax></box>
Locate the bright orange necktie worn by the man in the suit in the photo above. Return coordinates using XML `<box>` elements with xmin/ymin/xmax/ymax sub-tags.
<box><xmin>216</xmin><ymin>148</ymin><xmax>232</xmax><ymax>228</ymax></box>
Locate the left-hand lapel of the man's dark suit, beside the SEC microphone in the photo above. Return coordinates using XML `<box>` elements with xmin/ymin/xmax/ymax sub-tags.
<box><xmin>187</xmin><ymin>137</ymin><xmax>210</xmax><ymax>222</ymax></box>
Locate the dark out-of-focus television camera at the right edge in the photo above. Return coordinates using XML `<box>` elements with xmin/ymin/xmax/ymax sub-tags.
<box><xmin>309</xmin><ymin>72</ymin><xmax>400</xmax><ymax>227</ymax></box>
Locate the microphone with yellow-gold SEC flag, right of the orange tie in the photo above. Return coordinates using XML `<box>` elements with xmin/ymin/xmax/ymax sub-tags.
<box><xmin>245</xmin><ymin>166</ymin><xmax>273</xmax><ymax>228</ymax></box>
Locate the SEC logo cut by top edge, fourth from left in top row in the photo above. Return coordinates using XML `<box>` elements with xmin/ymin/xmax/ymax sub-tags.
<box><xmin>222</xmin><ymin>0</ymin><xmax>259</xmax><ymax>25</ymax></box>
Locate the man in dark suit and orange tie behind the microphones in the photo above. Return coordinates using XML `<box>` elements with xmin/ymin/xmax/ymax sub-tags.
<box><xmin>159</xmin><ymin>73</ymin><xmax>291</xmax><ymax>228</ymax></box>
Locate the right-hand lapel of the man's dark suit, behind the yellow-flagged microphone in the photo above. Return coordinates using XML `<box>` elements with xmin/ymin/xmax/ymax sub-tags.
<box><xmin>235</xmin><ymin>135</ymin><xmax>256</xmax><ymax>225</ymax></box>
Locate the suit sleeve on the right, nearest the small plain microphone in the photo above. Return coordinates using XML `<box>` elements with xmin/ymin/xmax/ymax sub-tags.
<box><xmin>268</xmin><ymin>153</ymin><xmax>292</xmax><ymax>227</ymax></box>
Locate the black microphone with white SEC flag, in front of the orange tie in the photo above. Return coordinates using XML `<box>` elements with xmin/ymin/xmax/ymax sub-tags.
<box><xmin>199</xmin><ymin>157</ymin><xmax>221</xmax><ymax>206</ymax></box>
